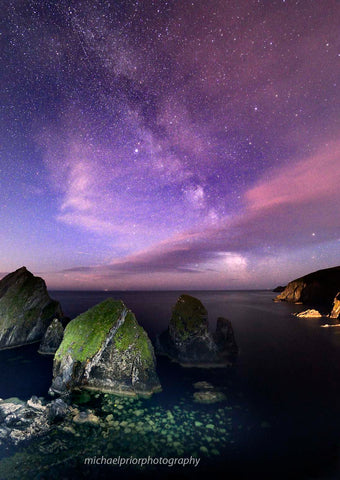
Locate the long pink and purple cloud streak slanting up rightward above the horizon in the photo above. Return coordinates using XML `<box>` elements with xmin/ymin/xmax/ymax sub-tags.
<box><xmin>59</xmin><ymin>139</ymin><xmax>340</xmax><ymax>280</ymax></box>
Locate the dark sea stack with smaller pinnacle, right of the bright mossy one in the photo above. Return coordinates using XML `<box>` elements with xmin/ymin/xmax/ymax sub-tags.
<box><xmin>156</xmin><ymin>295</ymin><xmax>237</xmax><ymax>367</ymax></box>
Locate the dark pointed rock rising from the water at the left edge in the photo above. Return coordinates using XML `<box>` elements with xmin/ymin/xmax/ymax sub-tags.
<box><xmin>0</xmin><ymin>267</ymin><xmax>63</xmax><ymax>349</ymax></box>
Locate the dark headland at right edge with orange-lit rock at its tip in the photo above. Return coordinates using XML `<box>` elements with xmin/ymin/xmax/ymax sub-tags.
<box><xmin>275</xmin><ymin>267</ymin><xmax>340</xmax><ymax>308</ymax></box>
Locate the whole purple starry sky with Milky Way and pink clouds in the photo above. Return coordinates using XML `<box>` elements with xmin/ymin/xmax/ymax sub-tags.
<box><xmin>0</xmin><ymin>0</ymin><xmax>340</xmax><ymax>290</ymax></box>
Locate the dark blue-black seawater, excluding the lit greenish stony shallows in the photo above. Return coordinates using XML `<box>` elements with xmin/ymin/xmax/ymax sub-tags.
<box><xmin>0</xmin><ymin>291</ymin><xmax>340</xmax><ymax>480</ymax></box>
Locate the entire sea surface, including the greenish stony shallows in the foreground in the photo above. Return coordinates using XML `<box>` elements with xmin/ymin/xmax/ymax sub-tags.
<box><xmin>0</xmin><ymin>291</ymin><xmax>340</xmax><ymax>479</ymax></box>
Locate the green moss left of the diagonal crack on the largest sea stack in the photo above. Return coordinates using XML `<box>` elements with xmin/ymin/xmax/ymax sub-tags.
<box><xmin>55</xmin><ymin>298</ymin><xmax>126</xmax><ymax>362</ymax></box>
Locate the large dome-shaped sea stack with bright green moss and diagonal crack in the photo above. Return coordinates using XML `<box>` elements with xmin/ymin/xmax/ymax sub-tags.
<box><xmin>50</xmin><ymin>299</ymin><xmax>161</xmax><ymax>396</ymax></box>
